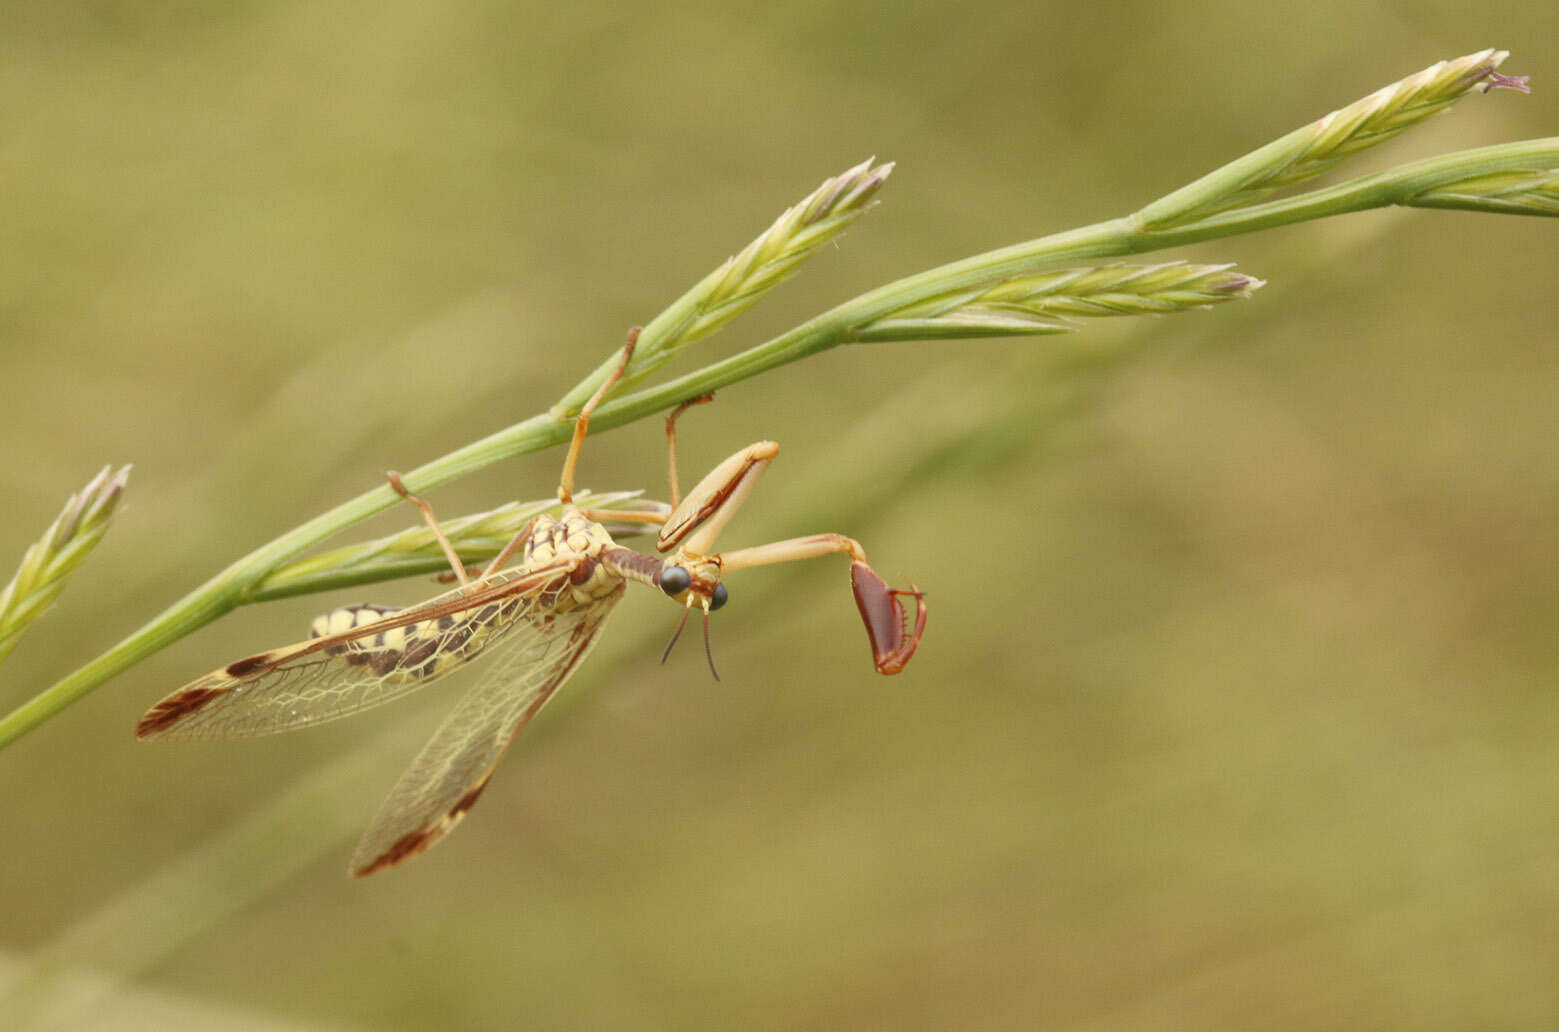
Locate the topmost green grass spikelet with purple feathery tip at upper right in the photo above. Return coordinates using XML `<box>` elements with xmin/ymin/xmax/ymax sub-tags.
<box><xmin>1137</xmin><ymin>50</ymin><xmax>1528</xmax><ymax>231</ymax></box>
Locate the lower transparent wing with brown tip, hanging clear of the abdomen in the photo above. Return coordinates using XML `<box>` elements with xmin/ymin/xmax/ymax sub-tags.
<box><xmin>351</xmin><ymin>585</ymin><xmax>624</xmax><ymax>878</ymax></box>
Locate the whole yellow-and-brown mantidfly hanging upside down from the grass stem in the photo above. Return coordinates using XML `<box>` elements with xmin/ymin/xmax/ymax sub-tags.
<box><xmin>136</xmin><ymin>329</ymin><xmax>926</xmax><ymax>876</ymax></box>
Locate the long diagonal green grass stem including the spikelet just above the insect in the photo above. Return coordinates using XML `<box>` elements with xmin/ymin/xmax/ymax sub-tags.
<box><xmin>0</xmin><ymin>51</ymin><xmax>1559</xmax><ymax>757</ymax></box>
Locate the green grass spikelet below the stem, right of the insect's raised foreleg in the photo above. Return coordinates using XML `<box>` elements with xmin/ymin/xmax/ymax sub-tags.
<box><xmin>856</xmin><ymin>262</ymin><xmax>1264</xmax><ymax>341</ymax></box>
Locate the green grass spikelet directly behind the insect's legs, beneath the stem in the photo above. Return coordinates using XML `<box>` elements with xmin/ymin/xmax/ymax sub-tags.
<box><xmin>245</xmin><ymin>491</ymin><xmax>670</xmax><ymax>602</ymax></box>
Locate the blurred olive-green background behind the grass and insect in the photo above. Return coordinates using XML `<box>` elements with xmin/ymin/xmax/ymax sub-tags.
<box><xmin>0</xmin><ymin>0</ymin><xmax>1559</xmax><ymax>1029</ymax></box>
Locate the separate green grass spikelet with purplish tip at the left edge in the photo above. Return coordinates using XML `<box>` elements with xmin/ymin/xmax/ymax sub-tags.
<box><xmin>0</xmin><ymin>466</ymin><xmax>129</xmax><ymax>659</ymax></box>
